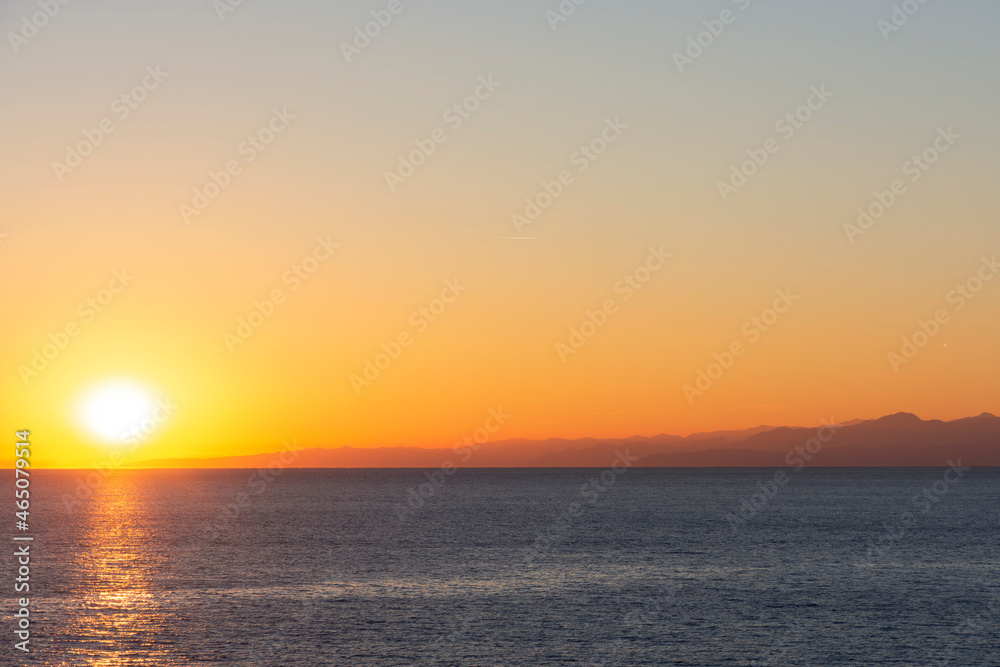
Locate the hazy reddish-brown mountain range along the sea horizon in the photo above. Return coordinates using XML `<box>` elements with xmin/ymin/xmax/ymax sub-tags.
<box><xmin>131</xmin><ymin>412</ymin><xmax>1000</xmax><ymax>468</ymax></box>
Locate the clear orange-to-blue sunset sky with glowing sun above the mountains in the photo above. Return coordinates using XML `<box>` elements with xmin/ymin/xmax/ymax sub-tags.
<box><xmin>0</xmin><ymin>0</ymin><xmax>1000</xmax><ymax>466</ymax></box>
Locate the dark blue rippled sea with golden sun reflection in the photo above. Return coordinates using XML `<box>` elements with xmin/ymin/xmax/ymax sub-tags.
<box><xmin>2</xmin><ymin>462</ymin><xmax>1000</xmax><ymax>667</ymax></box>
